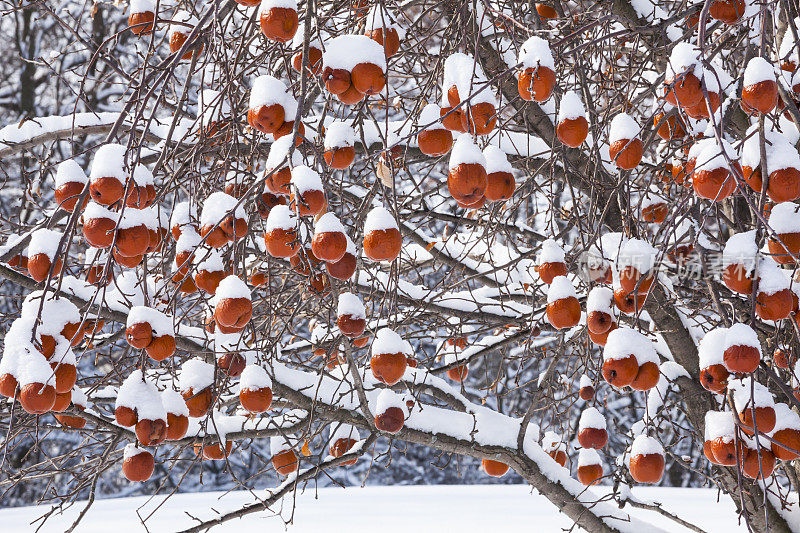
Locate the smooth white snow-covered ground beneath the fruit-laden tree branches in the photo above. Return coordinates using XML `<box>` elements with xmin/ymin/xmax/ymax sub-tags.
<box><xmin>0</xmin><ymin>485</ymin><xmax>746</xmax><ymax>533</ymax></box>
